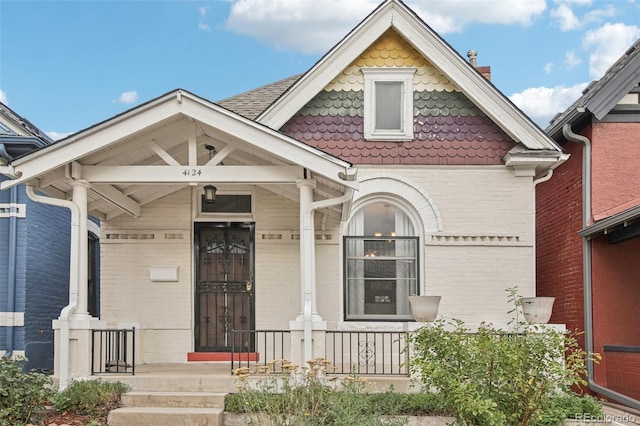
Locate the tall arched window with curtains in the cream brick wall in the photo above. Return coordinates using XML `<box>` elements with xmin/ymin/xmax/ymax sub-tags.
<box><xmin>344</xmin><ymin>200</ymin><xmax>419</xmax><ymax>320</ymax></box>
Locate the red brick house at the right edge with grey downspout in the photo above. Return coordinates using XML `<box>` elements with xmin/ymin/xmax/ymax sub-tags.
<box><xmin>536</xmin><ymin>40</ymin><xmax>640</xmax><ymax>408</ymax></box>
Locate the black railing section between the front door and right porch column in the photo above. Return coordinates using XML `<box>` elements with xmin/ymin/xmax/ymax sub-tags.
<box><xmin>231</xmin><ymin>330</ymin><xmax>291</xmax><ymax>373</ymax></box>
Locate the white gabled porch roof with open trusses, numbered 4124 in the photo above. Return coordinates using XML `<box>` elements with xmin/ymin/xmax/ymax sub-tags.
<box><xmin>0</xmin><ymin>89</ymin><xmax>357</xmax><ymax>223</ymax></box>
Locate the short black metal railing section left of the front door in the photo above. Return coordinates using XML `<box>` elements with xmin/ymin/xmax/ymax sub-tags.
<box><xmin>91</xmin><ymin>327</ymin><xmax>136</xmax><ymax>375</ymax></box>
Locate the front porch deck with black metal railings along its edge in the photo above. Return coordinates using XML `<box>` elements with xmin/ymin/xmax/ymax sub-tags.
<box><xmin>87</xmin><ymin>323</ymin><xmax>418</xmax><ymax>377</ymax></box>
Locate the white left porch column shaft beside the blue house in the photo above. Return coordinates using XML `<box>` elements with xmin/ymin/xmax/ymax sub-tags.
<box><xmin>71</xmin><ymin>179</ymin><xmax>91</xmax><ymax>317</ymax></box>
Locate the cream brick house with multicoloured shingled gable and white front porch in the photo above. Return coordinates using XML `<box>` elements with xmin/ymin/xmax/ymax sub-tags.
<box><xmin>0</xmin><ymin>0</ymin><xmax>565</xmax><ymax>385</ymax></box>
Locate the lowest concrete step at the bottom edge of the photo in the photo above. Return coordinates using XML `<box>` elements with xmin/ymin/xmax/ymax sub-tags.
<box><xmin>107</xmin><ymin>407</ymin><xmax>224</xmax><ymax>426</ymax></box>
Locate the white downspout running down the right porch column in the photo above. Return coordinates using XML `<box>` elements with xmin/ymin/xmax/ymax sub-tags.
<box><xmin>302</xmin><ymin>187</ymin><xmax>353</xmax><ymax>361</ymax></box>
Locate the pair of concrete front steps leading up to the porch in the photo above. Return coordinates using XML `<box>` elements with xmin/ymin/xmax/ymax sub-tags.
<box><xmin>107</xmin><ymin>391</ymin><xmax>225</xmax><ymax>426</ymax></box>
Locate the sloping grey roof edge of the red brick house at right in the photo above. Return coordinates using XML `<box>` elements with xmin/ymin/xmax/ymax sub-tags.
<box><xmin>546</xmin><ymin>39</ymin><xmax>640</xmax><ymax>140</ymax></box>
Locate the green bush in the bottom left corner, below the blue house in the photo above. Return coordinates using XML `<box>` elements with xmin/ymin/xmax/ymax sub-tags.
<box><xmin>0</xmin><ymin>357</ymin><xmax>55</xmax><ymax>426</ymax></box>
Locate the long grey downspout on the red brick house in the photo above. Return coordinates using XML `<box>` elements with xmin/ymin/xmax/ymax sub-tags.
<box><xmin>562</xmin><ymin>123</ymin><xmax>640</xmax><ymax>410</ymax></box>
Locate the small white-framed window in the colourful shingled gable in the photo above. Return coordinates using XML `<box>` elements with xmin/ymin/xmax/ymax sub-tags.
<box><xmin>362</xmin><ymin>67</ymin><xmax>416</xmax><ymax>141</ymax></box>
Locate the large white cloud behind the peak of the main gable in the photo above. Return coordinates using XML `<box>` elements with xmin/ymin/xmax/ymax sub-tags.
<box><xmin>225</xmin><ymin>0</ymin><xmax>546</xmax><ymax>53</ymax></box>
